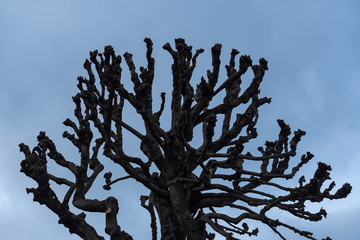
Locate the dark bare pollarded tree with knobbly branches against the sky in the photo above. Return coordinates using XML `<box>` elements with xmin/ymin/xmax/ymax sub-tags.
<box><xmin>20</xmin><ymin>38</ymin><xmax>351</xmax><ymax>240</ymax></box>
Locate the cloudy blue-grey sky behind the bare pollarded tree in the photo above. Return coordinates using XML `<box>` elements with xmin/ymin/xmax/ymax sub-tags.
<box><xmin>0</xmin><ymin>0</ymin><xmax>360</xmax><ymax>240</ymax></box>
